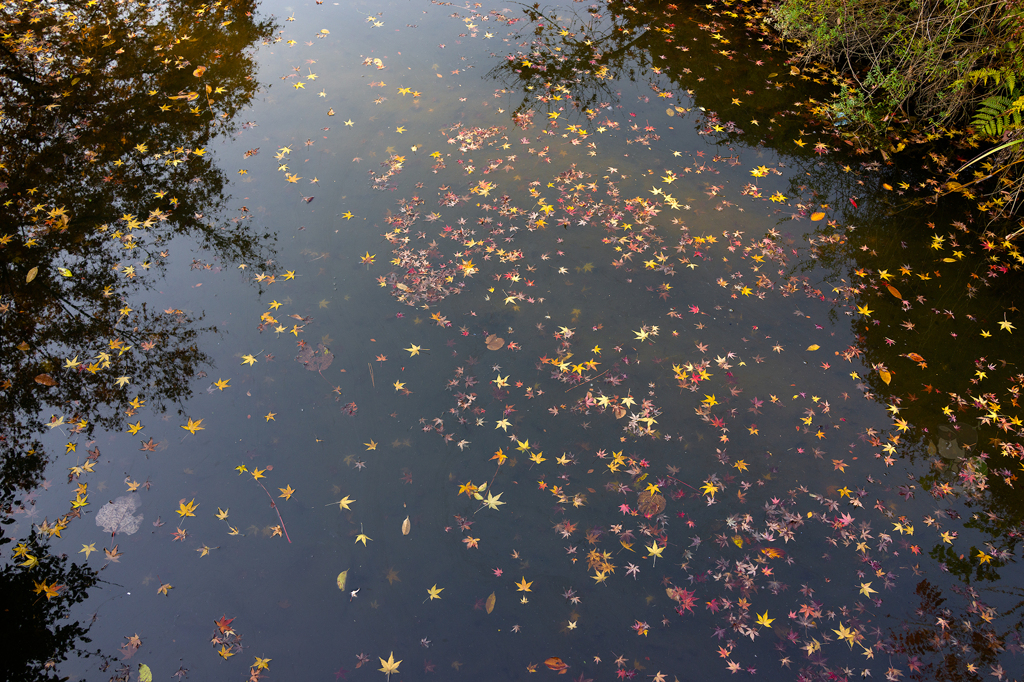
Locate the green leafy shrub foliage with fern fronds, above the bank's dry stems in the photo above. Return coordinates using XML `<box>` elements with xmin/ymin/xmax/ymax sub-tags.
<box><xmin>771</xmin><ymin>0</ymin><xmax>1024</xmax><ymax>133</ymax></box>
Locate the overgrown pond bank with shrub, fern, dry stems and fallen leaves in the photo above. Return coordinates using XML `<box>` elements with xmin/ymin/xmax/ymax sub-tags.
<box><xmin>717</xmin><ymin>0</ymin><xmax>1024</xmax><ymax>231</ymax></box>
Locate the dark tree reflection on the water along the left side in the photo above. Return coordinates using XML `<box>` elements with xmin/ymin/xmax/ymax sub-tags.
<box><xmin>0</xmin><ymin>0</ymin><xmax>274</xmax><ymax>680</ymax></box>
